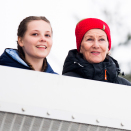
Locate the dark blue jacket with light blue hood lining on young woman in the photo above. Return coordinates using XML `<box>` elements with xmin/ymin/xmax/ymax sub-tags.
<box><xmin>0</xmin><ymin>48</ymin><xmax>57</xmax><ymax>74</ymax></box>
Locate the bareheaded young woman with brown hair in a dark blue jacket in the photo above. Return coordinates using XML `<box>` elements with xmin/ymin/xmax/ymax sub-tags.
<box><xmin>0</xmin><ymin>16</ymin><xmax>56</xmax><ymax>74</ymax></box>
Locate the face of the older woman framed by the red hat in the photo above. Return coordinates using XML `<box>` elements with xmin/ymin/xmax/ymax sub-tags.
<box><xmin>80</xmin><ymin>29</ymin><xmax>109</xmax><ymax>63</ymax></box>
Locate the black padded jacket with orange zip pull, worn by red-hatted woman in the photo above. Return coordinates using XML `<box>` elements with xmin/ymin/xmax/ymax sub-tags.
<box><xmin>62</xmin><ymin>49</ymin><xmax>131</xmax><ymax>86</ymax></box>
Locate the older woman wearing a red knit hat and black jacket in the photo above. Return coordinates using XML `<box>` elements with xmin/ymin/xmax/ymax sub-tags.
<box><xmin>62</xmin><ymin>18</ymin><xmax>131</xmax><ymax>85</ymax></box>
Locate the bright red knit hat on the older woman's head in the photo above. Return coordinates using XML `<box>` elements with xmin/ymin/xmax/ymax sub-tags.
<box><xmin>75</xmin><ymin>18</ymin><xmax>111</xmax><ymax>52</ymax></box>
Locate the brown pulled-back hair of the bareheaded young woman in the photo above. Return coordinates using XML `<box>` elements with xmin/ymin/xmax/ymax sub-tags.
<box><xmin>17</xmin><ymin>16</ymin><xmax>53</xmax><ymax>71</ymax></box>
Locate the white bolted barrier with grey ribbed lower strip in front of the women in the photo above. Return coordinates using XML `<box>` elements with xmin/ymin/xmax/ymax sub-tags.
<box><xmin>0</xmin><ymin>66</ymin><xmax>131</xmax><ymax>131</ymax></box>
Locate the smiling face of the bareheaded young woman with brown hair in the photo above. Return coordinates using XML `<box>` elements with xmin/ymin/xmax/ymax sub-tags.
<box><xmin>18</xmin><ymin>20</ymin><xmax>52</xmax><ymax>61</ymax></box>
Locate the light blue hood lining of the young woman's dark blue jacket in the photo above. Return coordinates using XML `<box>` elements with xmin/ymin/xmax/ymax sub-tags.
<box><xmin>5</xmin><ymin>49</ymin><xmax>29</xmax><ymax>67</ymax></box>
